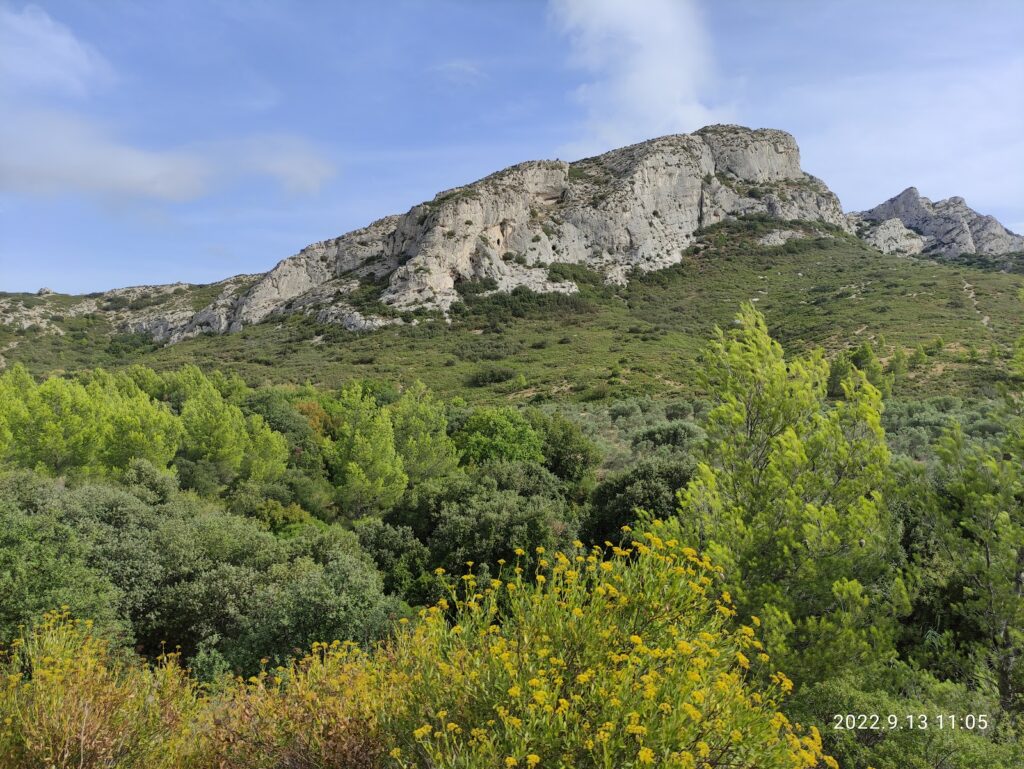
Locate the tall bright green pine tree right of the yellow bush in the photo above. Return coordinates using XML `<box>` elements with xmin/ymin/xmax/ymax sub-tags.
<box><xmin>679</xmin><ymin>305</ymin><xmax>902</xmax><ymax>680</ymax></box>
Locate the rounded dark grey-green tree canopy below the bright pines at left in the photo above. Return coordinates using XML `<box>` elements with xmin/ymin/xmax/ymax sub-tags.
<box><xmin>0</xmin><ymin>473</ymin><xmax>399</xmax><ymax>673</ymax></box>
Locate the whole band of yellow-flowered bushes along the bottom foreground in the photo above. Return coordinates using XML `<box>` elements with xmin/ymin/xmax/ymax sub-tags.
<box><xmin>0</xmin><ymin>521</ymin><xmax>829</xmax><ymax>769</ymax></box>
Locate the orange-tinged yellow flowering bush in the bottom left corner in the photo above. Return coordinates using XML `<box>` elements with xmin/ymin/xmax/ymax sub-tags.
<box><xmin>0</xmin><ymin>611</ymin><xmax>202</xmax><ymax>769</ymax></box>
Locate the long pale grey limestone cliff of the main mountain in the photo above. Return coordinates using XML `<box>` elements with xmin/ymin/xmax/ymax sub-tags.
<box><xmin>4</xmin><ymin>126</ymin><xmax>853</xmax><ymax>341</ymax></box>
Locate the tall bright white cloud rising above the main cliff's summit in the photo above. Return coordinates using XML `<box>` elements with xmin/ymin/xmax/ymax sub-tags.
<box><xmin>550</xmin><ymin>0</ymin><xmax>729</xmax><ymax>154</ymax></box>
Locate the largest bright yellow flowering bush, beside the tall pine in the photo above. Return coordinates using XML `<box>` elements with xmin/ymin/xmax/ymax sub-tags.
<box><xmin>382</xmin><ymin>521</ymin><xmax>822</xmax><ymax>769</ymax></box>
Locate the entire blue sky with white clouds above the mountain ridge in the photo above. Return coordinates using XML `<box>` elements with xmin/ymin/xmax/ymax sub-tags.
<box><xmin>0</xmin><ymin>0</ymin><xmax>1024</xmax><ymax>293</ymax></box>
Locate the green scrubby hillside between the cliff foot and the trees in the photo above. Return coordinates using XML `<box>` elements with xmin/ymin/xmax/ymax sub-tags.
<box><xmin>0</xmin><ymin>220</ymin><xmax>1024</xmax><ymax>402</ymax></box>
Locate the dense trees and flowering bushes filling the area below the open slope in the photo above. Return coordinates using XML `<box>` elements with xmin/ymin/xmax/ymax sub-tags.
<box><xmin>0</xmin><ymin>305</ymin><xmax>1024</xmax><ymax>769</ymax></box>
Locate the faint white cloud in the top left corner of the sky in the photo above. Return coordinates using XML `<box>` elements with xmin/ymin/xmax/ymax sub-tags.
<box><xmin>0</xmin><ymin>5</ymin><xmax>113</xmax><ymax>97</ymax></box>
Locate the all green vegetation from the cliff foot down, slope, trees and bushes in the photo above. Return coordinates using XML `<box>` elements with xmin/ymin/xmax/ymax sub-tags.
<box><xmin>0</xmin><ymin>127</ymin><xmax>1024</xmax><ymax>769</ymax></box>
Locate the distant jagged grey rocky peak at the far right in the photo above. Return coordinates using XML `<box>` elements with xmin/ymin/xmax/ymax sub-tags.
<box><xmin>859</xmin><ymin>187</ymin><xmax>1024</xmax><ymax>256</ymax></box>
